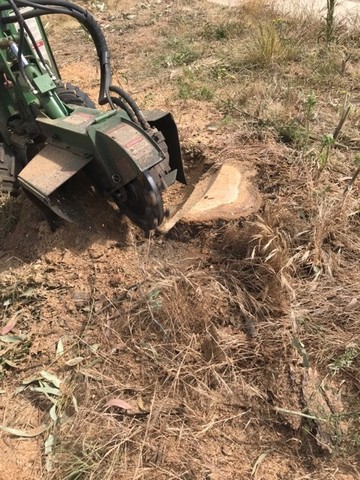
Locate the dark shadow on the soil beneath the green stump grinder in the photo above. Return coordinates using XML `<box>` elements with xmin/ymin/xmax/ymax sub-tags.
<box><xmin>0</xmin><ymin>188</ymin><xmax>129</xmax><ymax>272</ymax></box>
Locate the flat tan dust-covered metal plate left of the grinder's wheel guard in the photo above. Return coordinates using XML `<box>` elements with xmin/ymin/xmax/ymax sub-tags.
<box><xmin>18</xmin><ymin>145</ymin><xmax>91</xmax><ymax>197</ymax></box>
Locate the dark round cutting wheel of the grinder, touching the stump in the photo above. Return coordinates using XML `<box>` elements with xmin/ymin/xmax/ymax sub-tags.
<box><xmin>113</xmin><ymin>171</ymin><xmax>164</xmax><ymax>232</ymax></box>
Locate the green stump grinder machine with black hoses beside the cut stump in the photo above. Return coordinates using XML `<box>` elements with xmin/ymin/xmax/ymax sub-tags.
<box><xmin>0</xmin><ymin>0</ymin><xmax>186</xmax><ymax>231</ymax></box>
